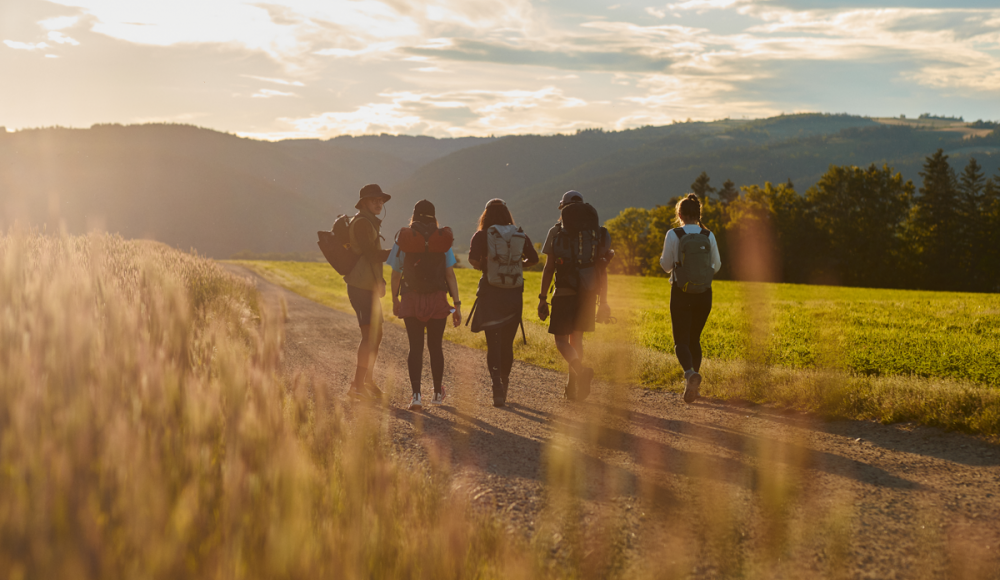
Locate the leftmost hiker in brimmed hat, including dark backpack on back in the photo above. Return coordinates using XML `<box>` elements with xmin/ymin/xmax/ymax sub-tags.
<box><xmin>318</xmin><ymin>183</ymin><xmax>391</xmax><ymax>400</ymax></box>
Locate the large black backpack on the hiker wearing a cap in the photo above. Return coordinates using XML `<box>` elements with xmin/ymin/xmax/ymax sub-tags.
<box><xmin>552</xmin><ymin>203</ymin><xmax>611</xmax><ymax>294</ymax></box>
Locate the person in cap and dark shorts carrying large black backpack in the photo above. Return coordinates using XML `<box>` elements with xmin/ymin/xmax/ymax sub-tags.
<box><xmin>538</xmin><ymin>190</ymin><xmax>614</xmax><ymax>401</ymax></box>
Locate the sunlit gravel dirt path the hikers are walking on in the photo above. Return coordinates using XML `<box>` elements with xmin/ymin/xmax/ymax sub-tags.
<box><xmin>227</xmin><ymin>266</ymin><xmax>1000</xmax><ymax>578</ymax></box>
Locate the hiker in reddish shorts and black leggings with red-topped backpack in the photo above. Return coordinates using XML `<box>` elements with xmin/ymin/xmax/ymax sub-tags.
<box><xmin>386</xmin><ymin>199</ymin><xmax>462</xmax><ymax>411</ymax></box>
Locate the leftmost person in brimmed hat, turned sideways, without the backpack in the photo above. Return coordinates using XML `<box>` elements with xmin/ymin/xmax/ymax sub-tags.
<box><xmin>344</xmin><ymin>183</ymin><xmax>390</xmax><ymax>400</ymax></box>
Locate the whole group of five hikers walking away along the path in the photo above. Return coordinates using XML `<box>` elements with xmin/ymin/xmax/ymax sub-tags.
<box><xmin>319</xmin><ymin>184</ymin><xmax>721</xmax><ymax>410</ymax></box>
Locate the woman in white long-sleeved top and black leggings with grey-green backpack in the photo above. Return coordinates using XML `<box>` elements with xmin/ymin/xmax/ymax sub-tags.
<box><xmin>660</xmin><ymin>193</ymin><xmax>722</xmax><ymax>403</ymax></box>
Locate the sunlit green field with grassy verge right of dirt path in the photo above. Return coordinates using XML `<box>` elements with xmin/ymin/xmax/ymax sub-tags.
<box><xmin>230</xmin><ymin>262</ymin><xmax>1000</xmax><ymax>438</ymax></box>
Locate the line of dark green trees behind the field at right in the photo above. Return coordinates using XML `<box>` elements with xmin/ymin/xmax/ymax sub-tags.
<box><xmin>605</xmin><ymin>149</ymin><xmax>1000</xmax><ymax>292</ymax></box>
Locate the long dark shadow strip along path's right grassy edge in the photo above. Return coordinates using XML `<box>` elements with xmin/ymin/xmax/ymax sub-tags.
<box><xmin>700</xmin><ymin>399</ymin><xmax>1000</xmax><ymax>467</ymax></box>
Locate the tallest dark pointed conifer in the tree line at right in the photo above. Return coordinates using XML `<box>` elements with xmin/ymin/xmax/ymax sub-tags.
<box><xmin>906</xmin><ymin>149</ymin><xmax>965</xmax><ymax>290</ymax></box>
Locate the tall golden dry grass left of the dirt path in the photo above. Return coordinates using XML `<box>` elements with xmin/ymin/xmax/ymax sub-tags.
<box><xmin>0</xmin><ymin>232</ymin><xmax>531</xmax><ymax>580</ymax></box>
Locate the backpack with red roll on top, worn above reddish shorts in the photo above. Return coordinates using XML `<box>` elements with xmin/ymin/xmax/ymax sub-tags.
<box><xmin>396</xmin><ymin>222</ymin><xmax>455</xmax><ymax>294</ymax></box>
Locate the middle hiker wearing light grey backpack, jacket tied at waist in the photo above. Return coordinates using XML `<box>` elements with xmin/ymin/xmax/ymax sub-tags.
<box><xmin>466</xmin><ymin>199</ymin><xmax>538</xmax><ymax>407</ymax></box>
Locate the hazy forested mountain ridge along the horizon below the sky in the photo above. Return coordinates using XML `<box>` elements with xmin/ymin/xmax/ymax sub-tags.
<box><xmin>0</xmin><ymin>114</ymin><xmax>1000</xmax><ymax>258</ymax></box>
